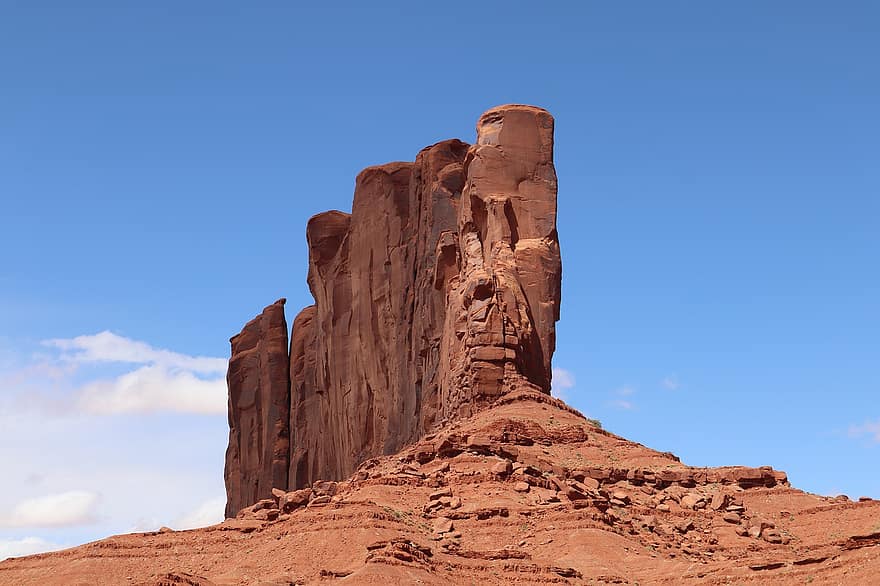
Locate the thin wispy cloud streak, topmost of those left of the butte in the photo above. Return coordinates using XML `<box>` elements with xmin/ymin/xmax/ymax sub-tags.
<box><xmin>43</xmin><ymin>331</ymin><xmax>226</xmax><ymax>374</ymax></box>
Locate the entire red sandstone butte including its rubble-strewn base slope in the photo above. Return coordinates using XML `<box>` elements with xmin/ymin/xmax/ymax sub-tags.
<box><xmin>0</xmin><ymin>105</ymin><xmax>880</xmax><ymax>586</ymax></box>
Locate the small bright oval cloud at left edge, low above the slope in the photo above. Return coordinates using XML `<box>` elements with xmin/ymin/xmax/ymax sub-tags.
<box><xmin>0</xmin><ymin>490</ymin><xmax>98</xmax><ymax>527</ymax></box>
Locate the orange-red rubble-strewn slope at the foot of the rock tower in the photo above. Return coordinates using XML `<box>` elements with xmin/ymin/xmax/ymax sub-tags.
<box><xmin>0</xmin><ymin>391</ymin><xmax>880</xmax><ymax>586</ymax></box>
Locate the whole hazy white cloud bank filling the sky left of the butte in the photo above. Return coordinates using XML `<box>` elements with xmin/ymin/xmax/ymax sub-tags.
<box><xmin>0</xmin><ymin>334</ymin><xmax>229</xmax><ymax>558</ymax></box>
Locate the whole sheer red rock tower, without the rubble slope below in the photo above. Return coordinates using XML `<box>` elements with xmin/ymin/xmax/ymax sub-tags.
<box><xmin>226</xmin><ymin>105</ymin><xmax>561</xmax><ymax>515</ymax></box>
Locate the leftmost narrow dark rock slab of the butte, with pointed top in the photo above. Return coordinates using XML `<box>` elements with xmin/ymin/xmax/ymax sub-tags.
<box><xmin>225</xmin><ymin>299</ymin><xmax>290</xmax><ymax>516</ymax></box>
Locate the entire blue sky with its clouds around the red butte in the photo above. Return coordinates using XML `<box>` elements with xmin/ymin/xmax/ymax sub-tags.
<box><xmin>0</xmin><ymin>0</ymin><xmax>880</xmax><ymax>558</ymax></box>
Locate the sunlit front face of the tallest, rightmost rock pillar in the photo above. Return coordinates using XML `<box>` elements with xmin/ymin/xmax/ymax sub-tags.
<box><xmin>438</xmin><ymin>106</ymin><xmax>562</xmax><ymax>417</ymax></box>
